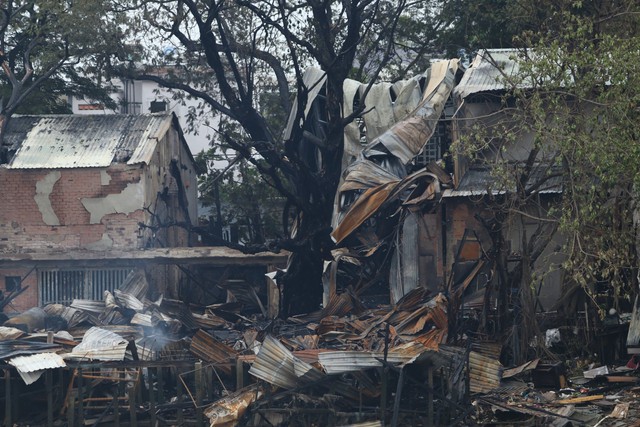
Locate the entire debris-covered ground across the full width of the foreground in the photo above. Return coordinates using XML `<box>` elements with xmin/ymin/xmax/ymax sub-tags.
<box><xmin>0</xmin><ymin>268</ymin><xmax>640</xmax><ymax>426</ymax></box>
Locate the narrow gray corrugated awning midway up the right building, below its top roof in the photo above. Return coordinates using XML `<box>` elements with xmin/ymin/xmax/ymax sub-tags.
<box><xmin>442</xmin><ymin>165</ymin><xmax>563</xmax><ymax>197</ymax></box>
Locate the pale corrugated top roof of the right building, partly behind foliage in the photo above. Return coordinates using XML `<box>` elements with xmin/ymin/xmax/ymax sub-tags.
<box><xmin>453</xmin><ymin>49</ymin><xmax>519</xmax><ymax>98</ymax></box>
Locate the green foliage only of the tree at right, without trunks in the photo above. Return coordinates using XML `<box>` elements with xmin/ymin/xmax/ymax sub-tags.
<box><xmin>459</xmin><ymin>1</ymin><xmax>640</xmax><ymax>314</ymax></box>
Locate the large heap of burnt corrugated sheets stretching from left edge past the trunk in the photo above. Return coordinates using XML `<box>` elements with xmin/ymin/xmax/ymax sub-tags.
<box><xmin>0</xmin><ymin>266</ymin><xmax>501</xmax><ymax>426</ymax></box>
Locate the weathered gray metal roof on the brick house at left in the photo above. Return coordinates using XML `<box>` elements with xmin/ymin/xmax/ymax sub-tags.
<box><xmin>4</xmin><ymin>113</ymin><xmax>178</xmax><ymax>169</ymax></box>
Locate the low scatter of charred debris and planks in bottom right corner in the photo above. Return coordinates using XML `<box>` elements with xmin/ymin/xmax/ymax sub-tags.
<box><xmin>473</xmin><ymin>358</ymin><xmax>640</xmax><ymax>427</ymax></box>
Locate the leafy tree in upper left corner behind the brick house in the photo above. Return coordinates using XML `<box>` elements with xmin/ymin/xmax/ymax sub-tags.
<box><xmin>0</xmin><ymin>0</ymin><xmax>129</xmax><ymax>162</ymax></box>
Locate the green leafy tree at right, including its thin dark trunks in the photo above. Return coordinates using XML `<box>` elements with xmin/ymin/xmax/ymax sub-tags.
<box><xmin>456</xmin><ymin>1</ymin><xmax>640</xmax><ymax>358</ymax></box>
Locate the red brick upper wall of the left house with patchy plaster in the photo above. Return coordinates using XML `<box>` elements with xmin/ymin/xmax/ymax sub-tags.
<box><xmin>0</xmin><ymin>165</ymin><xmax>144</xmax><ymax>253</ymax></box>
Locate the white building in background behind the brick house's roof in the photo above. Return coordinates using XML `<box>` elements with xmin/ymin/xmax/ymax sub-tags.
<box><xmin>68</xmin><ymin>80</ymin><xmax>219</xmax><ymax>156</ymax></box>
